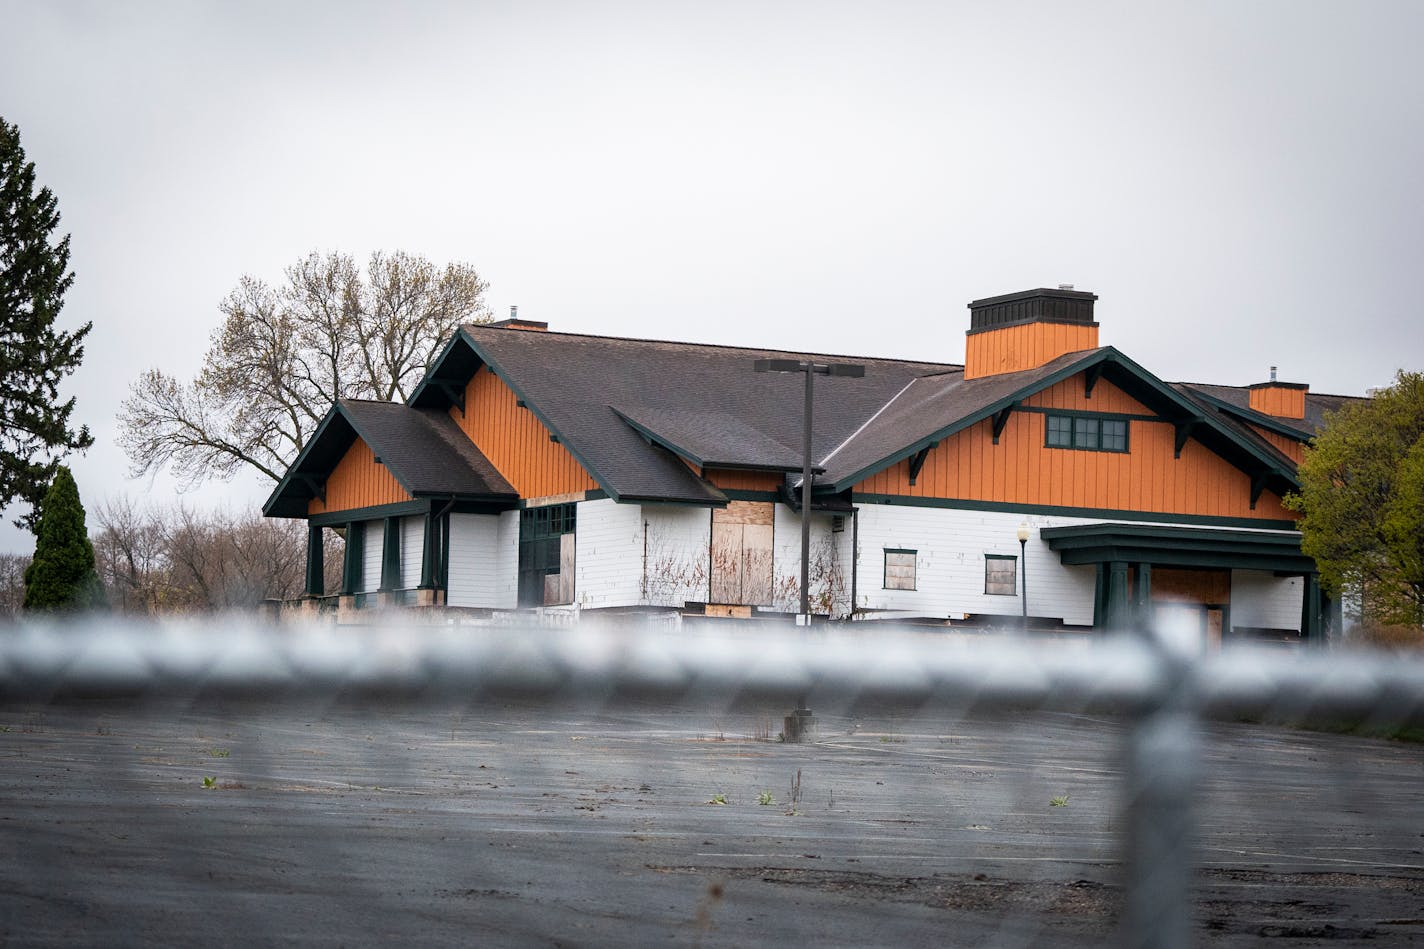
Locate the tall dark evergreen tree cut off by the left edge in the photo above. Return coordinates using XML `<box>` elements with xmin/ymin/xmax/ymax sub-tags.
<box><xmin>0</xmin><ymin>118</ymin><xmax>94</xmax><ymax>530</ymax></box>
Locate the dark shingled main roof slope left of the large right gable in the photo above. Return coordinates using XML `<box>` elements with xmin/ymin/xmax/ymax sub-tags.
<box><xmin>412</xmin><ymin>325</ymin><xmax>960</xmax><ymax>503</ymax></box>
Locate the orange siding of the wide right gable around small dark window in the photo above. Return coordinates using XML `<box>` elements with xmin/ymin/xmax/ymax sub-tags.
<box><xmin>856</xmin><ymin>398</ymin><xmax>1294</xmax><ymax>520</ymax></box>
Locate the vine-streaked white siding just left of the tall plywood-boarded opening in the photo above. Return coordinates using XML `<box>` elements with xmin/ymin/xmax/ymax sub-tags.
<box><xmin>637</xmin><ymin>504</ymin><xmax>712</xmax><ymax>607</ymax></box>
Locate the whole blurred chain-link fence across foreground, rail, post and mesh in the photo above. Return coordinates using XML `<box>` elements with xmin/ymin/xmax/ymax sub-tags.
<box><xmin>0</xmin><ymin>618</ymin><xmax>1424</xmax><ymax>946</ymax></box>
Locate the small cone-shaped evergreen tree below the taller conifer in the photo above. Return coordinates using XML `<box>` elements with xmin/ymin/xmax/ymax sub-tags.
<box><xmin>24</xmin><ymin>465</ymin><xmax>104</xmax><ymax>610</ymax></box>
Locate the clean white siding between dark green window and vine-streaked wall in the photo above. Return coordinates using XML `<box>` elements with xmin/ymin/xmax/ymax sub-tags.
<box><xmin>574</xmin><ymin>497</ymin><xmax>642</xmax><ymax>610</ymax></box>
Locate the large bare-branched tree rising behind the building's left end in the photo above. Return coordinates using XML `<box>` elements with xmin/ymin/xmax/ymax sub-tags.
<box><xmin>118</xmin><ymin>251</ymin><xmax>488</xmax><ymax>483</ymax></box>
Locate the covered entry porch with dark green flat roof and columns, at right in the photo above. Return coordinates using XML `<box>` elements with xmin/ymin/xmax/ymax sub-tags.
<box><xmin>1040</xmin><ymin>523</ymin><xmax>1340</xmax><ymax>643</ymax></box>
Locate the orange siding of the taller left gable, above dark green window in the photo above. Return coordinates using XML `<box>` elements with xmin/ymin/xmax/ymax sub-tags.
<box><xmin>450</xmin><ymin>366</ymin><xmax>598</xmax><ymax>497</ymax></box>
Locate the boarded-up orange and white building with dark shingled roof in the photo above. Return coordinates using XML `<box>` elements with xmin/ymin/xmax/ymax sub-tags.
<box><xmin>263</xmin><ymin>289</ymin><xmax>1346</xmax><ymax>641</ymax></box>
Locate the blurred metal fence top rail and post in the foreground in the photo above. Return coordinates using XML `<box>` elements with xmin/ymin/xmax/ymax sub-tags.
<box><xmin>0</xmin><ymin>617</ymin><xmax>1424</xmax><ymax>946</ymax></box>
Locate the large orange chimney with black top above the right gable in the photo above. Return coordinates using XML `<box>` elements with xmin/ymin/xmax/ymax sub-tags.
<box><xmin>964</xmin><ymin>284</ymin><xmax>1098</xmax><ymax>379</ymax></box>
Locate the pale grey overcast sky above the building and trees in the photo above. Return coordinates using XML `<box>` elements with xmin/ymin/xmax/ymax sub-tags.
<box><xmin>0</xmin><ymin>0</ymin><xmax>1424</xmax><ymax>551</ymax></box>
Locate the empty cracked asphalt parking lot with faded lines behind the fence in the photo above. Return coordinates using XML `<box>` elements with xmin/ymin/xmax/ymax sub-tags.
<box><xmin>0</xmin><ymin>692</ymin><xmax>1424</xmax><ymax>946</ymax></box>
